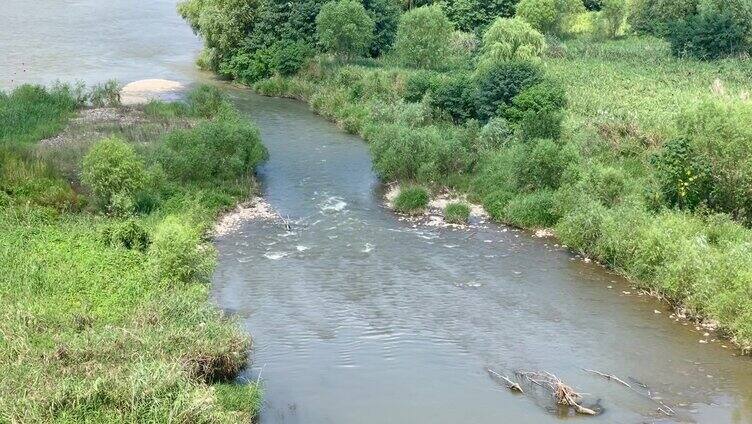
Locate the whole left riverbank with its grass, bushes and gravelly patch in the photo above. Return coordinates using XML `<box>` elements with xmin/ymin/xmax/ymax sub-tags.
<box><xmin>0</xmin><ymin>86</ymin><xmax>266</xmax><ymax>423</ymax></box>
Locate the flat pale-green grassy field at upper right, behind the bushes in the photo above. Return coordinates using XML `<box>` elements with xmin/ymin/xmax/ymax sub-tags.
<box><xmin>544</xmin><ymin>36</ymin><xmax>752</xmax><ymax>138</ymax></box>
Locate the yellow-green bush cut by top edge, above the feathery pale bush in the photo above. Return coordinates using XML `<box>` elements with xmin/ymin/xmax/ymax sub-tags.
<box><xmin>517</xmin><ymin>0</ymin><xmax>584</xmax><ymax>35</ymax></box>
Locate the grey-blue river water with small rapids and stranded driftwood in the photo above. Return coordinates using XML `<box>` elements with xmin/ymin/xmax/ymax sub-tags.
<box><xmin>0</xmin><ymin>0</ymin><xmax>752</xmax><ymax>424</ymax></box>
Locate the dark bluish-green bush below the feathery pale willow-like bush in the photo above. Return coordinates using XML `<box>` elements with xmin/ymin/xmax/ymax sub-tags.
<box><xmin>478</xmin><ymin>61</ymin><xmax>543</xmax><ymax>122</ymax></box>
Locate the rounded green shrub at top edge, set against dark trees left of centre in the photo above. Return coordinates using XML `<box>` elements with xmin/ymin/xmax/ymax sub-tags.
<box><xmin>316</xmin><ymin>0</ymin><xmax>374</xmax><ymax>59</ymax></box>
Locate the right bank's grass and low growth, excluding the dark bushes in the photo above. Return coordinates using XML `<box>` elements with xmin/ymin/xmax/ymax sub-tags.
<box><xmin>248</xmin><ymin>37</ymin><xmax>752</xmax><ymax>349</ymax></box>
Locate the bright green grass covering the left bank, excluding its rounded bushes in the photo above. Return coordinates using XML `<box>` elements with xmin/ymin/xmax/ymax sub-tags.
<box><xmin>0</xmin><ymin>87</ymin><xmax>261</xmax><ymax>423</ymax></box>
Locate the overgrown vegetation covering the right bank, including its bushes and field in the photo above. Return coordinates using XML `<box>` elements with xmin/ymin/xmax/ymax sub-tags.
<box><xmin>184</xmin><ymin>0</ymin><xmax>752</xmax><ymax>348</ymax></box>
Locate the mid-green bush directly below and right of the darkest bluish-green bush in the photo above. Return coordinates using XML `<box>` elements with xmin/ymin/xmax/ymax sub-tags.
<box><xmin>503</xmin><ymin>81</ymin><xmax>567</xmax><ymax>140</ymax></box>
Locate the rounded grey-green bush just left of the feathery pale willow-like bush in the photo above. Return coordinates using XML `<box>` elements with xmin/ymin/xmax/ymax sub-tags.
<box><xmin>395</xmin><ymin>5</ymin><xmax>454</xmax><ymax>69</ymax></box>
